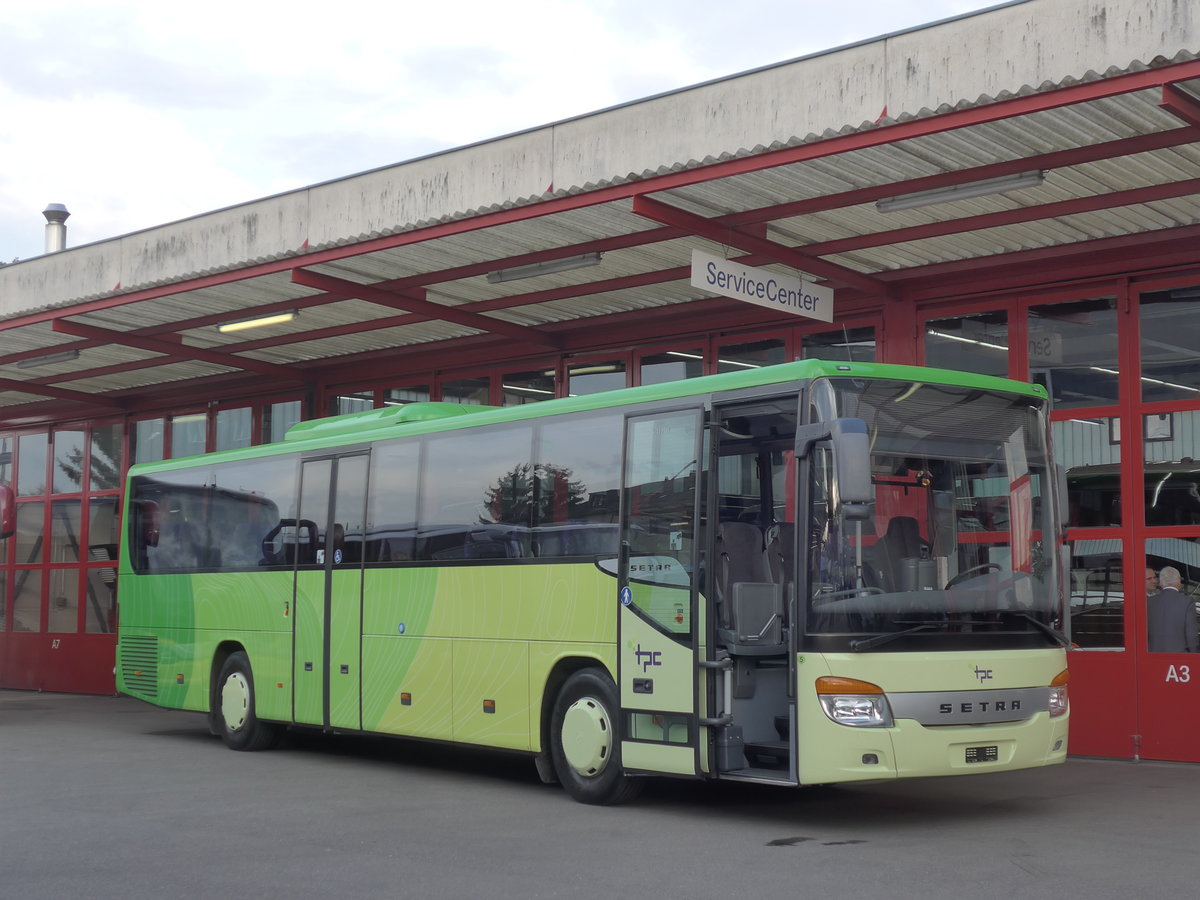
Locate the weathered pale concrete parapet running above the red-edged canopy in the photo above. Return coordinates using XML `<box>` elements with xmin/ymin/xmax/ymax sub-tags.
<box><xmin>0</xmin><ymin>0</ymin><xmax>1200</xmax><ymax>318</ymax></box>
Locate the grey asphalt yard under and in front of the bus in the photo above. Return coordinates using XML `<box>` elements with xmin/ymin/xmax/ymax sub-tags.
<box><xmin>0</xmin><ymin>691</ymin><xmax>1200</xmax><ymax>900</ymax></box>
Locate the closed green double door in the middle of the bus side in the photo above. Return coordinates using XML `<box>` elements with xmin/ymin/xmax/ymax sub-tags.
<box><xmin>293</xmin><ymin>454</ymin><xmax>368</xmax><ymax>730</ymax></box>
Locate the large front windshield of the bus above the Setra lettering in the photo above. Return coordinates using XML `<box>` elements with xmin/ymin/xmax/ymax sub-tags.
<box><xmin>805</xmin><ymin>378</ymin><xmax>1066</xmax><ymax>652</ymax></box>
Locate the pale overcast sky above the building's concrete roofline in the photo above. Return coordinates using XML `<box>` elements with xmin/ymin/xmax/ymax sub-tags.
<box><xmin>0</xmin><ymin>0</ymin><xmax>996</xmax><ymax>262</ymax></box>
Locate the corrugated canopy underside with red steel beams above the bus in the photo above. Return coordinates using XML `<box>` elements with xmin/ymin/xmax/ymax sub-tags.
<box><xmin>0</xmin><ymin>54</ymin><xmax>1200</xmax><ymax>419</ymax></box>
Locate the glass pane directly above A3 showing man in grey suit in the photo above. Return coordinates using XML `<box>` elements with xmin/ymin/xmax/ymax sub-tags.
<box><xmin>1146</xmin><ymin>538</ymin><xmax>1200</xmax><ymax>653</ymax></box>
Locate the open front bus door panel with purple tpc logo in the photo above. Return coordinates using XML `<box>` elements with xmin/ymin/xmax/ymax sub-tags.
<box><xmin>617</xmin><ymin>409</ymin><xmax>707</xmax><ymax>775</ymax></box>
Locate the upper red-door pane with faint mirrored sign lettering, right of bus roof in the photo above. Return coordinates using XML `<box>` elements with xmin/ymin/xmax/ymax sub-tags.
<box><xmin>1028</xmin><ymin>296</ymin><xmax>1117</xmax><ymax>409</ymax></box>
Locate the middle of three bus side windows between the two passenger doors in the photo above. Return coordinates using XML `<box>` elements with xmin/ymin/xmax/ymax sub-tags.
<box><xmin>416</xmin><ymin>425</ymin><xmax>533</xmax><ymax>559</ymax></box>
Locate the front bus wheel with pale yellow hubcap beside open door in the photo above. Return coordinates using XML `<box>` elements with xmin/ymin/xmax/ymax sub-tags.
<box><xmin>550</xmin><ymin>668</ymin><xmax>642</xmax><ymax>805</ymax></box>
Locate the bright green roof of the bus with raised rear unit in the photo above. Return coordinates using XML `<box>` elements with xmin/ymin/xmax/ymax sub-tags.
<box><xmin>131</xmin><ymin>359</ymin><xmax>1046</xmax><ymax>474</ymax></box>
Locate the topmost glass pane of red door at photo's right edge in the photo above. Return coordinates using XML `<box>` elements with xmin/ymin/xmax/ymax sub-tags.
<box><xmin>1139</xmin><ymin>286</ymin><xmax>1200</xmax><ymax>401</ymax></box>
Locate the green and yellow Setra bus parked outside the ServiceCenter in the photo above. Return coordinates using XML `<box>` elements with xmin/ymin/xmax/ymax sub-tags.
<box><xmin>116</xmin><ymin>360</ymin><xmax>1069</xmax><ymax>803</ymax></box>
